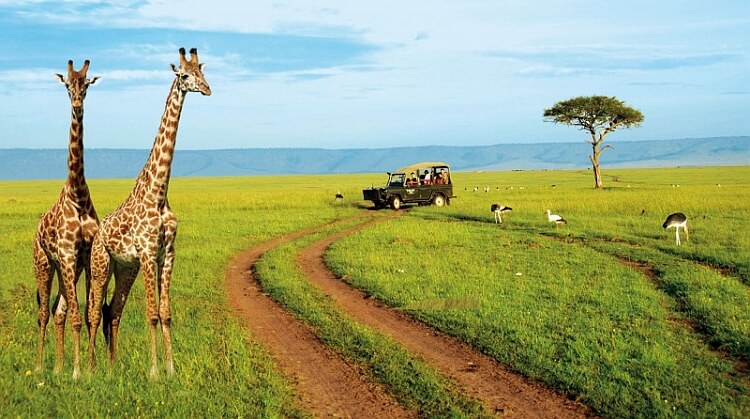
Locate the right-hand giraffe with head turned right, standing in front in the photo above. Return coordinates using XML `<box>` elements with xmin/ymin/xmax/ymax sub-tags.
<box><xmin>88</xmin><ymin>48</ymin><xmax>211</xmax><ymax>378</ymax></box>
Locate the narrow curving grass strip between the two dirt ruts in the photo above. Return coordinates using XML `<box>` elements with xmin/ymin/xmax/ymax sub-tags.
<box><xmin>256</xmin><ymin>218</ymin><xmax>490</xmax><ymax>417</ymax></box>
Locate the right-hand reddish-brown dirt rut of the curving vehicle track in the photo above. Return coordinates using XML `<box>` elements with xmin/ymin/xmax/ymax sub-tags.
<box><xmin>298</xmin><ymin>223</ymin><xmax>593</xmax><ymax>418</ymax></box>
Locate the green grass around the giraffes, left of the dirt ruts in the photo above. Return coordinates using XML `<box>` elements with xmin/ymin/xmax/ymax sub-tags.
<box><xmin>0</xmin><ymin>176</ymin><xmax>358</xmax><ymax>417</ymax></box>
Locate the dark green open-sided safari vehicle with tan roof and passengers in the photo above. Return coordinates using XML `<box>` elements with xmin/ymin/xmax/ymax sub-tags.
<box><xmin>362</xmin><ymin>162</ymin><xmax>454</xmax><ymax>210</ymax></box>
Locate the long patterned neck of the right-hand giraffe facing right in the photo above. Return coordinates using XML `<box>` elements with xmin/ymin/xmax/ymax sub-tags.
<box><xmin>133</xmin><ymin>79</ymin><xmax>185</xmax><ymax>204</ymax></box>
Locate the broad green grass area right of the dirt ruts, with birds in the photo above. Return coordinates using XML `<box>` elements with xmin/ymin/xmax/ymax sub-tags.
<box><xmin>327</xmin><ymin>168</ymin><xmax>750</xmax><ymax>417</ymax></box>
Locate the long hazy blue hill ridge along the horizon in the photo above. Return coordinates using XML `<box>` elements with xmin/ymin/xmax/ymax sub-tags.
<box><xmin>0</xmin><ymin>136</ymin><xmax>750</xmax><ymax>180</ymax></box>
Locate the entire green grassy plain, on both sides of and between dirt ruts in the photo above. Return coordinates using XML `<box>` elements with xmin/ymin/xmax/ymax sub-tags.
<box><xmin>0</xmin><ymin>167</ymin><xmax>750</xmax><ymax>418</ymax></box>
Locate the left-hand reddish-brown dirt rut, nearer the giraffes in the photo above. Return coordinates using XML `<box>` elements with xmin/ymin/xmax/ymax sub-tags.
<box><xmin>227</xmin><ymin>213</ymin><xmax>416</xmax><ymax>418</ymax></box>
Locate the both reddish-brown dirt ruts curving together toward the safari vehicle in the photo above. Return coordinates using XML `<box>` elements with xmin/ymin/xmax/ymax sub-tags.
<box><xmin>227</xmin><ymin>214</ymin><xmax>591</xmax><ymax>418</ymax></box>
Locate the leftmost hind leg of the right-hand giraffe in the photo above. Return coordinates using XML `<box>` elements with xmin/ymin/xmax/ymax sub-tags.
<box><xmin>86</xmin><ymin>240</ymin><xmax>112</xmax><ymax>372</ymax></box>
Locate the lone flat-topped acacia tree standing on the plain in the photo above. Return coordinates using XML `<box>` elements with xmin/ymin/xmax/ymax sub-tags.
<box><xmin>544</xmin><ymin>96</ymin><xmax>643</xmax><ymax>189</ymax></box>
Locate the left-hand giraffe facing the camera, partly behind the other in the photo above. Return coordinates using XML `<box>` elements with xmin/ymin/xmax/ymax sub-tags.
<box><xmin>34</xmin><ymin>60</ymin><xmax>99</xmax><ymax>379</ymax></box>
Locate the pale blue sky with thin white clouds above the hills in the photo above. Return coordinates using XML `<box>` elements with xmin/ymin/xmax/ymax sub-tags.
<box><xmin>0</xmin><ymin>0</ymin><xmax>750</xmax><ymax>149</ymax></box>
